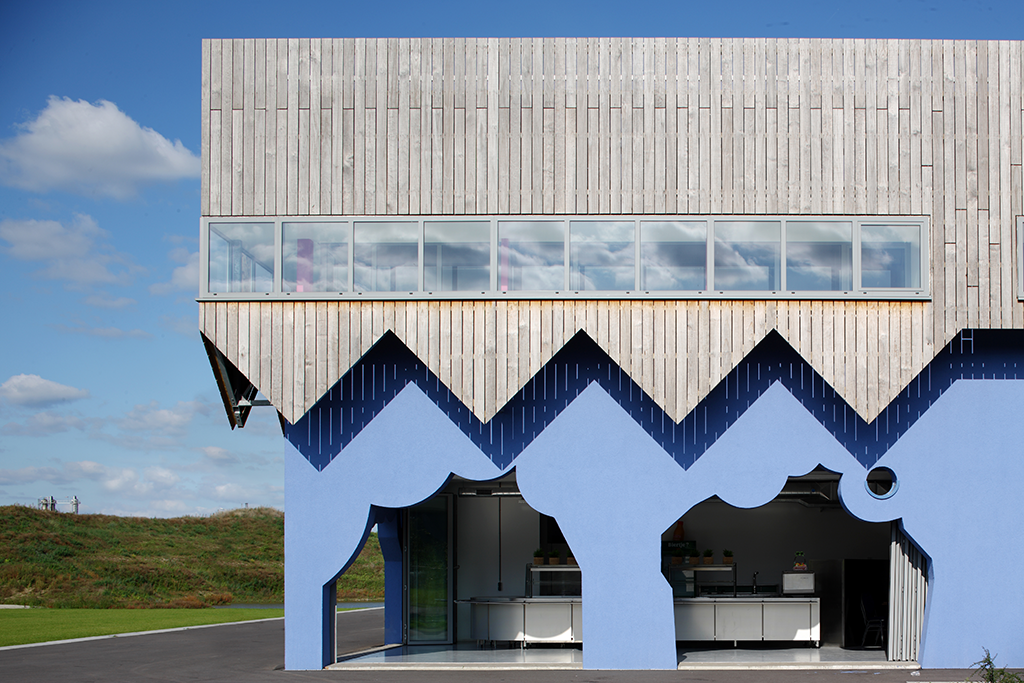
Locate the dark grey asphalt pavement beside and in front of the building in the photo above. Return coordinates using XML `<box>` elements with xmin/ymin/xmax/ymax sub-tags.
<box><xmin>0</xmin><ymin>609</ymin><xmax>971</xmax><ymax>683</ymax></box>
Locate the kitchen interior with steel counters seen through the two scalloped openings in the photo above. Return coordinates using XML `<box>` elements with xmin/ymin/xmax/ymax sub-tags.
<box><xmin>415</xmin><ymin>469</ymin><xmax>890</xmax><ymax>651</ymax></box>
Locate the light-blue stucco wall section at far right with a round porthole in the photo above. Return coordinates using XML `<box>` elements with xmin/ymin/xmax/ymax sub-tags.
<box><xmin>840</xmin><ymin>380</ymin><xmax>1024</xmax><ymax>668</ymax></box>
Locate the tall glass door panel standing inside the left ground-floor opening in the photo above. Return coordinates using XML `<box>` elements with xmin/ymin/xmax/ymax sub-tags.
<box><xmin>406</xmin><ymin>494</ymin><xmax>454</xmax><ymax>645</ymax></box>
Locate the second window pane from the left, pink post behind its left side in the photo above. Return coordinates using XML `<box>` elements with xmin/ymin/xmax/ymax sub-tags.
<box><xmin>282</xmin><ymin>223</ymin><xmax>349</xmax><ymax>292</ymax></box>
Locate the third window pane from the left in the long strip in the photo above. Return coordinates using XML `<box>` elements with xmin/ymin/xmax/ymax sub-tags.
<box><xmin>353</xmin><ymin>222</ymin><xmax>420</xmax><ymax>292</ymax></box>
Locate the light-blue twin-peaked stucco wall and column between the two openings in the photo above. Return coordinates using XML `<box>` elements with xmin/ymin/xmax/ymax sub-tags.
<box><xmin>515</xmin><ymin>384</ymin><xmax>863</xmax><ymax>669</ymax></box>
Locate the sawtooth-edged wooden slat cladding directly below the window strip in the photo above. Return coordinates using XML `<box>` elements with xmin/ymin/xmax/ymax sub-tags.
<box><xmin>200</xmin><ymin>300</ymin><xmax>941</xmax><ymax>422</ymax></box>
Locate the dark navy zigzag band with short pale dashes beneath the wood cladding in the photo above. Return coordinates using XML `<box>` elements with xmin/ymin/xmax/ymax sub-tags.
<box><xmin>286</xmin><ymin>330</ymin><xmax>1024</xmax><ymax>469</ymax></box>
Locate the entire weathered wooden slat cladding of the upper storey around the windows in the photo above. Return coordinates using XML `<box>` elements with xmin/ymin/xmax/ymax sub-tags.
<box><xmin>201</xmin><ymin>38</ymin><xmax>1024</xmax><ymax>428</ymax></box>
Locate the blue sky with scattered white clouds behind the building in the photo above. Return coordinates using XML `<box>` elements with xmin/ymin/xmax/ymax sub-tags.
<box><xmin>0</xmin><ymin>0</ymin><xmax>1024</xmax><ymax>516</ymax></box>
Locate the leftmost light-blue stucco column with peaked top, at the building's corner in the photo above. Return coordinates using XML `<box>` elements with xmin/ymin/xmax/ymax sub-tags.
<box><xmin>285</xmin><ymin>384</ymin><xmax>503</xmax><ymax>670</ymax></box>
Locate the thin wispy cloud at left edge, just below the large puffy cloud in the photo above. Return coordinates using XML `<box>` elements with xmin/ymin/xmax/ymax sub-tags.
<box><xmin>0</xmin><ymin>214</ymin><xmax>144</xmax><ymax>287</ymax></box>
